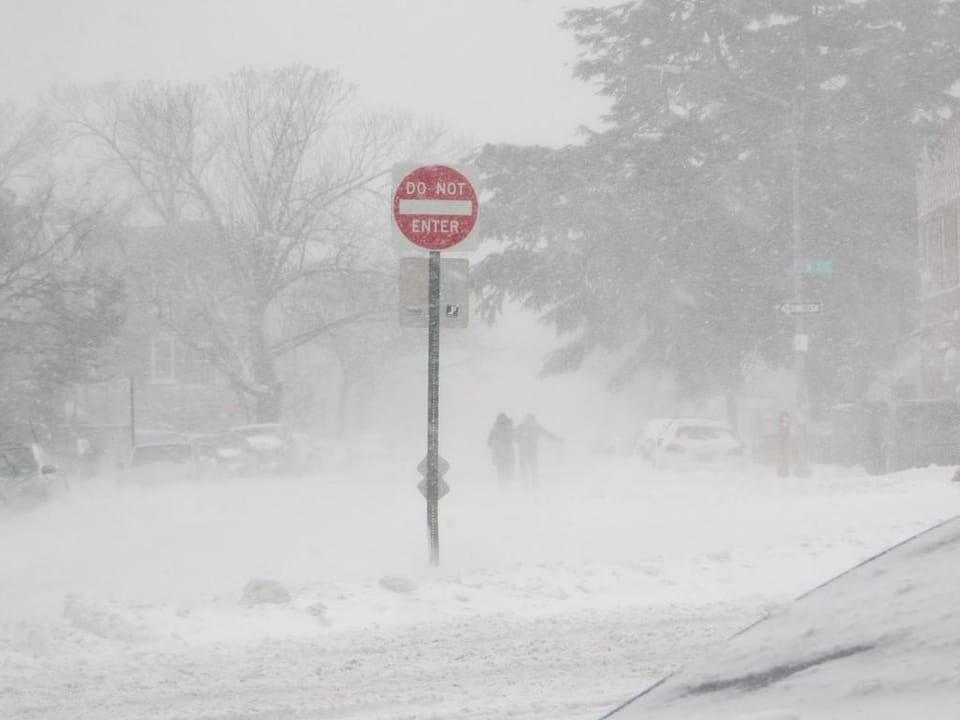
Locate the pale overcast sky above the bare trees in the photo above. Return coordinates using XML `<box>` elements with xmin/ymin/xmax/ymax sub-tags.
<box><xmin>0</xmin><ymin>0</ymin><xmax>612</xmax><ymax>145</ymax></box>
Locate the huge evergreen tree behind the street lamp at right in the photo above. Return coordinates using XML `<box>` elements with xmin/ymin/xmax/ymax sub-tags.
<box><xmin>478</xmin><ymin>0</ymin><xmax>960</xmax><ymax>404</ymax></box>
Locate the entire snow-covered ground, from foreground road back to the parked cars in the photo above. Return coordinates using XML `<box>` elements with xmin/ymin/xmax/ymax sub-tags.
<box><xmin>0</xmin><ymin>451</ymin><xmax>960</xmax><ymax>720</ymax></box>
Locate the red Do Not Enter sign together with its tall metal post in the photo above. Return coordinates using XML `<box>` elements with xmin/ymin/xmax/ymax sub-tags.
<box><xmin>393</xmin><ymin>165</ymin><xmax>479</xmax><ymax>565</ymax></box>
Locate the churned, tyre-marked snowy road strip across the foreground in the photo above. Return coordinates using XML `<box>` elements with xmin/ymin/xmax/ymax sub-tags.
<box><xmin>3</xmin><ymin>606</ymin><xmax>744</xmax><ymax>720</ymax></box>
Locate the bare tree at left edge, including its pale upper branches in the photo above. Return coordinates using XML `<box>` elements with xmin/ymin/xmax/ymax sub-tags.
<box><xmin>0</xmin><ymin>105</ymin><xmax>122</xmax><ymax>422</ymax></box>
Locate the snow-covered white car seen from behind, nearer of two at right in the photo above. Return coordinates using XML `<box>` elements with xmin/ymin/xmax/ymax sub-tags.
<box><xmin>653</xmin><ymin>418</ymin><xmax>744</xmax><ymax>468</ymax></box>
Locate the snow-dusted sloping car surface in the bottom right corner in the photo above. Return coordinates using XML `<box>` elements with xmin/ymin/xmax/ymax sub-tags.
<box><xmin>604</xmin><ymin>518</ymin><xmax>960</xmax><ymax>720</ymax></box>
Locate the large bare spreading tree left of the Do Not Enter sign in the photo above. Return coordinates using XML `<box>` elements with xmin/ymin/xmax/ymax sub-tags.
<box><xmin>59</xmin><ymin>66</ymin><xmax>438</xmax><ymax>421</ymax></box>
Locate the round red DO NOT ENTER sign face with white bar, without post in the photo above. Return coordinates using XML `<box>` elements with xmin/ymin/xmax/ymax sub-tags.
<box><xmin>393</xmin><ymin>165</ymin><xmax>479</xmax><ymax>250</ymax></box>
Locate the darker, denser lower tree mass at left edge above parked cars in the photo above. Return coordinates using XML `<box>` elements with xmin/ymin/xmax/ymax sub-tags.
<box><xmin>0</xmin><ymin>191</ymin><xmax>124</xmax><ymax>425</ymax></box>
